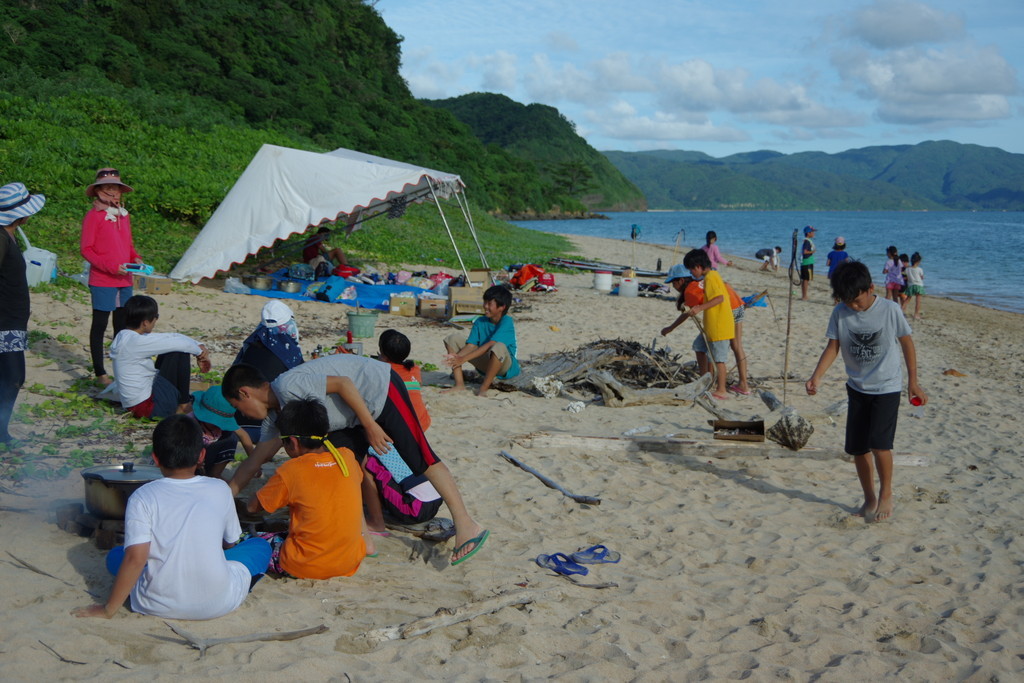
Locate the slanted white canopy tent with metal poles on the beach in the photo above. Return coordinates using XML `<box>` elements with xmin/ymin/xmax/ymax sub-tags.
<box><xmin>170</xmin><ymin>144</ymin><xmax>487</xmax><ymax>283</ymax></box>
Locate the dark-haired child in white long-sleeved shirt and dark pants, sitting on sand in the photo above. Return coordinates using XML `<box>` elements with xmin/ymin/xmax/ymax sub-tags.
<box><xmin>111</xmin><ymin>294</ymin><xmax>210</xmax><ymax>418</ymax></box>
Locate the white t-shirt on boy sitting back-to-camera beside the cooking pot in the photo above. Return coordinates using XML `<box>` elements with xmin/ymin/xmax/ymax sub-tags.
<box><xmin>125</xmin><ymin>476</ymin><xmax>252</xmax><ymax>620</ymax></box>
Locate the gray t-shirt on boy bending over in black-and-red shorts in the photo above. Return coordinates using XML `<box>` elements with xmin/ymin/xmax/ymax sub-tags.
<box><xmin>260</xmin><ymin>353</ymin><xmax>391</xmax><ymax>441</ymax></box>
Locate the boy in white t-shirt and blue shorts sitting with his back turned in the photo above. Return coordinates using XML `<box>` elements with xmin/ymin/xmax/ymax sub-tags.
<box><xmin>72</xmin><ymin>415</ymin><xmax>270</xmax><ymax>620</ymax></box>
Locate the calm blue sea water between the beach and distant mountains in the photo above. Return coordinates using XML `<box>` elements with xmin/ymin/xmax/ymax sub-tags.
<box><xmin>516</xmin><ymin>211</ymin><xmax>1024</xmax><ymax>312</ymax></box>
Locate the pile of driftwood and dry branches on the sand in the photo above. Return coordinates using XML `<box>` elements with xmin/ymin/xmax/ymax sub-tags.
<box><xmin>494</xmin><ymin>339</ymin><xmax>709</xmax><ymax>405</ymax></box>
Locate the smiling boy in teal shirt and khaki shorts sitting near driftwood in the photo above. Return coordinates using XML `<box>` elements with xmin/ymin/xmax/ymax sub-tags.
<box><xmin>444</xmin><ymin>285</ymin><xmax>519</xmax><ymax>396</ymax></box>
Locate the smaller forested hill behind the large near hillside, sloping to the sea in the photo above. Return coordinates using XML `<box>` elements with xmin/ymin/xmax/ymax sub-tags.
<box><xmin>424</xmin><ymin>92</ymin><xmax>647</xmax><ymax>211</ymax></box>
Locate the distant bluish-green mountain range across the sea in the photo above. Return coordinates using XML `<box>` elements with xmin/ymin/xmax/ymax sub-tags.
<box><xmin>603</xmin><ymin>140</ymin><xmax>1024</xmax><ymax>211</ymax></box>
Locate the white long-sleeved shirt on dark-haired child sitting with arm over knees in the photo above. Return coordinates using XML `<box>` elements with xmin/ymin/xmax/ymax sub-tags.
<box><xmin>111</xmin><ymin>330</ymin><xmax>203</xmax><ymax>411</ymax></box>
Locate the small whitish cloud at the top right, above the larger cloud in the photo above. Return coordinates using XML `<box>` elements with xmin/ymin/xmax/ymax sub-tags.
<box><xmin>845</xmin><ymin>0</ymin><xmax>965</xmax><ymax>49</ymax></box>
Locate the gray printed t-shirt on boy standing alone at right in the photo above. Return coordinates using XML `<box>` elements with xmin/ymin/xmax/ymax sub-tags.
<box><xmin>825</xmin><ymin>296</ymin><xmax>911</xmax><ymax>394</ymax></box>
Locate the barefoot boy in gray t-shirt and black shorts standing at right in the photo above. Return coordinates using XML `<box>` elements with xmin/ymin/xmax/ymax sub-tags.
<box><xmin>807</xmin><ymin>261</ymin><xmax>928</xmax><ymax>521</ymax></box>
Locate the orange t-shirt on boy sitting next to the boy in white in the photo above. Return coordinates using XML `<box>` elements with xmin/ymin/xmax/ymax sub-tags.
<box><xmin>256</xmin><ymin>449</ymin><xmax>367</xmax><ymax>579</ymax></box>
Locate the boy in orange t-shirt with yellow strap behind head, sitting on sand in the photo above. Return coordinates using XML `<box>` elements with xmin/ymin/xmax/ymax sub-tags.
<box><xmin>247</xmin><ymin>398</ymin><xmax>373</xmax><ymax>579</ymax></box>
